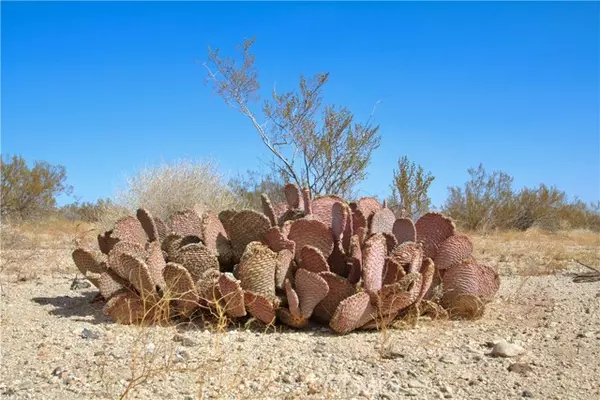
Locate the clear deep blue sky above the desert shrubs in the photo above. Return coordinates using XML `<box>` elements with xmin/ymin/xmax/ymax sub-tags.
<box><xmin>1</xmin><ymin>1</ymin><xmax>600</xmax><ymax>206</ymax></box>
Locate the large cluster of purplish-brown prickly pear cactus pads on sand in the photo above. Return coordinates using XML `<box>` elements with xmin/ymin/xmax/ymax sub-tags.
<box><xmin>72</xmin><ymin>183</ymin><xmax>500</xmax><ymax>334</ymax></box>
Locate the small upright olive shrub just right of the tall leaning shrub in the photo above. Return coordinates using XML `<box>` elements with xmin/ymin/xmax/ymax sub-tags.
<box><xmin>388</xmin><ymin>156</ymin><xmax>435</xmax><ymax>220</ymax></box>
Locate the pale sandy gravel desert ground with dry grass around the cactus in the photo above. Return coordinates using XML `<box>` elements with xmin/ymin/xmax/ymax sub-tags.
<box><xmin>0</xmin><ymin>221</ymin><xmax>600</xmax><ymax>400</ymax></box>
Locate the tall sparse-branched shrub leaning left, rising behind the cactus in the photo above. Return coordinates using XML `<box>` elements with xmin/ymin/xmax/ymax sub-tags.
<box><xmin>204</xmin><ymin>39</ymin><xmax>381</xmax><ymax>197</ymax></box>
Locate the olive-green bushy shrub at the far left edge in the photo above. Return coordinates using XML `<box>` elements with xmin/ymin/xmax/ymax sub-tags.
<box><xmin>0</xmin><ymin>155</ymin><xmax>72</xmax><ymax>220</ymax></box>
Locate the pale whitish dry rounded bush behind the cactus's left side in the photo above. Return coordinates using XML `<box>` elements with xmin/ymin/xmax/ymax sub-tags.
<box><xmin>100</xmin><ymin>159</ymin><xmax>245</xmax><ymax>228</ymax></box>
